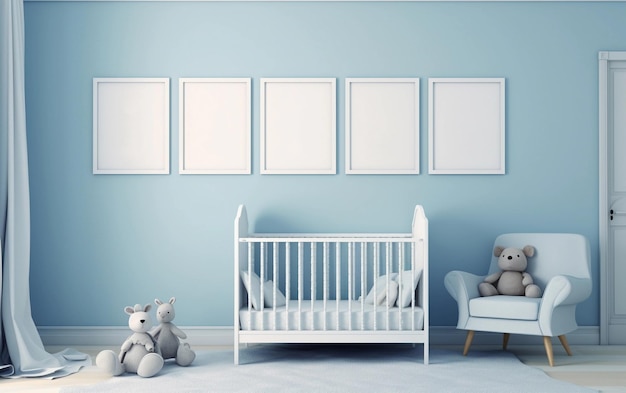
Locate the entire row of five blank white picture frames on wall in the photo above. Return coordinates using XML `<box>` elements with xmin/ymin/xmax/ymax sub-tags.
<box><xmin>93</xmin><ymin>78</ymin><xmax>505</xmax><ymax>174</ymax></box>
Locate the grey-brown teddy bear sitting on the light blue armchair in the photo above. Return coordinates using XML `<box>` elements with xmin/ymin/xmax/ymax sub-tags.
<box><xmin>478</xmin><ymin>246</ymin><xmax>541</xmax><ymax>297</ymax></box>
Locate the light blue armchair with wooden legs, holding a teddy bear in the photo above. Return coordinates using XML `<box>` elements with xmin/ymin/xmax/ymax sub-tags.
<box><xmin>444</xmin><ymin>233</ymin><xmax>592</xmax><ymax>366</ymax></box>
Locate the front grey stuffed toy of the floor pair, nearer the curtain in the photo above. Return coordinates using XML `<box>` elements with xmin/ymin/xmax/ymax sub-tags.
<box><xmin>96</xmin><ymin>304</ymin><xmax>163</xmax><ymax>378</ymax></box>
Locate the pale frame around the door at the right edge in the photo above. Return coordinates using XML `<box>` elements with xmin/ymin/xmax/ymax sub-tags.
<box><xmin>598</xmin><ymin>51</ymin><xmax>626</xmax><ymax>345</ymax></box>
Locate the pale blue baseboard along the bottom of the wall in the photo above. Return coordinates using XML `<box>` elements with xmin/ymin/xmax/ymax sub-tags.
<box><xmin>38</xmin><ymin>326</ymin><xmax>600</xmax><ymax>346</ymax></box>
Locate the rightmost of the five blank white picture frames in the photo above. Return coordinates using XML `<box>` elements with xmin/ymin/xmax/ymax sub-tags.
<box><xmin>428</xmin><ymin>78</ymin><xmax>506</xmax><ymax>174</ymax></box>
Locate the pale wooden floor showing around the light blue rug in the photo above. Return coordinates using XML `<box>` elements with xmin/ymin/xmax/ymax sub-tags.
<box><xmin>0</xmin><ymin>345</ymin><xmax>626</xmax><ymax>393</ymax></box>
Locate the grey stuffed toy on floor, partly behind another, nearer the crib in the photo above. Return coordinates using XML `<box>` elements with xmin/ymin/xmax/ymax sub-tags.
<box><xmin>150</xmin><ymin>297</ymin><xmax>196</xmax><ymax>367</ymax></box>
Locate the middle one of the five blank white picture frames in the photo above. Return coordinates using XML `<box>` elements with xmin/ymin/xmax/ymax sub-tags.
<box><xmin>260</xmin><ymin>78</ymin><xmax>337</xmax><ymax>174</ymax></box>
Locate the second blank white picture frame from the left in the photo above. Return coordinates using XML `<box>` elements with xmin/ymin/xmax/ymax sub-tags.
<box><xmin>178</xmin><ymin>78</ymin><xmax>252</xmax><ymax>174</ymax></box>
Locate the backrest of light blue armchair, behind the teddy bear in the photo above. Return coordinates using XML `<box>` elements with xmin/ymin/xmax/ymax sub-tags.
<box><xmin>489</xmin><ymin>233</ymin><xmax>591</xmax><ymax>289</ymax></box>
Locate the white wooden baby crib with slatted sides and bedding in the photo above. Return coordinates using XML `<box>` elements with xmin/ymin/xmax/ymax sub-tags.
<box><xmin>234</xmin><ymin>205</ymin><xmax>429</xmax><ymax>364</ymax></box>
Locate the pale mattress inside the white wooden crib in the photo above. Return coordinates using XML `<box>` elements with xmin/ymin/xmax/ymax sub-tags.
<box><xmin>239</xmin><ymin>300</ymin><xmax>424</xmax><ymax>331</ymax></box>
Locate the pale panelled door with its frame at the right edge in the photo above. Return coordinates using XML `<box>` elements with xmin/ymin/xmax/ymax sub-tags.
<box><xmin>599</xmin><ymin>52</ymin><xmax>626</xmax><ymax>344</ymax></box>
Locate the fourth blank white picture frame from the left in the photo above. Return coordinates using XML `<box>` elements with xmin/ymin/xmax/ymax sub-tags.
<box><xmin>345</xmin><ymin>78</ymin><xmax>420</xmax><ymax>174</ymax></box>
